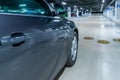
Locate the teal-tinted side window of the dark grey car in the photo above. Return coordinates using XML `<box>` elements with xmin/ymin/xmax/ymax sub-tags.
<box><xmin>0</xmin><ymin>0</ymin><xmax>50</xmax><ymax>15</ymax></box>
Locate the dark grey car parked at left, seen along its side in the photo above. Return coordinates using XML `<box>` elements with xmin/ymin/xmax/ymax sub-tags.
<box><xmin>0</xmin><ymin>0</ymin><xmax>78</xmax><ymax>80</ymax></box>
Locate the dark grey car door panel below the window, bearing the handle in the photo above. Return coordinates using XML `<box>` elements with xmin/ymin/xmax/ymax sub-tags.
<box><xmin>0</xmin><ymin>0</ymin><xmax>65</xmax><ymax>80</ymax></box>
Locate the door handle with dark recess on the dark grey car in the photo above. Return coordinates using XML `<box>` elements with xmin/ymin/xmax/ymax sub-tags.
<box><xmin>0</xmin><ymin>33</ymin><xmax>28</xmax><ymax>47</ymax></box>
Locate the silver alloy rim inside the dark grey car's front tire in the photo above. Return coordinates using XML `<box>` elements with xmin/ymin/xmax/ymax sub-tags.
<box><xmin>71</xmin><ymin>36</ymin><xmax>77</xmax><ymax>61</ymax></box>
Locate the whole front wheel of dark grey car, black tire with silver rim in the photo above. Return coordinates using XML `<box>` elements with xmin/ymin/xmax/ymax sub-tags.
<box><xmin>66</xmin><ymin>32</ymin><xmax>78</xmax><ymax>67</ymax></box>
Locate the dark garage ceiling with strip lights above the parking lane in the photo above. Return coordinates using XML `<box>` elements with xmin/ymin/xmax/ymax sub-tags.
<box><xmin>46</xmin><ymin>0</ymin><xmax>115</xmax><ymax>12</ymax></box>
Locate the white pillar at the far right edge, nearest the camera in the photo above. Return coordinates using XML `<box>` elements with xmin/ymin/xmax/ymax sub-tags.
<box><xmin>115</xmin><ymin>0</ymin><xmax>120</xmax><ymax>22</ymax></box>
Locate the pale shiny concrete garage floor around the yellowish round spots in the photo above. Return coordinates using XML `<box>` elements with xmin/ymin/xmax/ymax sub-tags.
<box><xmin>59</xmin><ymin>16</ymin><xmax>120</xmax><ymax>80</ymax></box>
